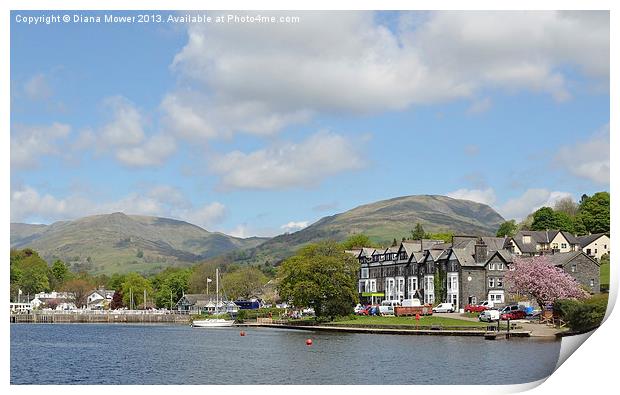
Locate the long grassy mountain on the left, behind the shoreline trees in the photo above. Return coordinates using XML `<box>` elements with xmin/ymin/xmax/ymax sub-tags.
<box><xmin>11</xmin><ymin>213</ymin><xmax>266</xmax><ymax>274</ymax></box>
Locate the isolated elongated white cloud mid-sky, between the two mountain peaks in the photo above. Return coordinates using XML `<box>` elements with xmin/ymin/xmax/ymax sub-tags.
<box><xmin>211</xmin><ymin>132</ymin><xmax>364</xmax><ymax>189</ymax></box>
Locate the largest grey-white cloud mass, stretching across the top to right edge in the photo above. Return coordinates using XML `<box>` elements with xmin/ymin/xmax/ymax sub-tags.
<box><xmin>162</xmin><ymin>11</ymin><xmax>609</xmax><ymax>139</ymax></box>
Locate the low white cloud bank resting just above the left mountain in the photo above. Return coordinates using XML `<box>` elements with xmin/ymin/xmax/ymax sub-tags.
<box><xmin>11</xmin><ymin>185</ymin><xmax>227</xmax><ymax>229</ymax></box>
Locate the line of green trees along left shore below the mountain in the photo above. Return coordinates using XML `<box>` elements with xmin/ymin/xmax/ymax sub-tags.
<box><xmin>10</xmin><ymin>248</ymin><xmax>275</xmax><ymax>309</ymax></box>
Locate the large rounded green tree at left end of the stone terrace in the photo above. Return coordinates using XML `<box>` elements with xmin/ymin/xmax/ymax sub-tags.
<box><xmin>278</xmin><ymin>241</ymin><xmax>359</xmax><ymax>319</ymax></box>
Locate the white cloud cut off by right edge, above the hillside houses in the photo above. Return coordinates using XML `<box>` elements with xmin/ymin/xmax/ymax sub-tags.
<box><xmin>555</xmin><ymin>125</ymin><xmax>610</xmax><ymax>185</ymax></box>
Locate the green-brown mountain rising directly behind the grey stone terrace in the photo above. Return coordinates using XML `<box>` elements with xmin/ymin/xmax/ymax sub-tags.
<box><xmin>228</xmin><ymin>195</ymin><xmax>504</xmax><ymax>263</ymax></box>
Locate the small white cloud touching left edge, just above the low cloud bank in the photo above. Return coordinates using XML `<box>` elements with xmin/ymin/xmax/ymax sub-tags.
<box><xmin>11</xmin><ymin>122</ymin><xmax>71</xmax><ymax>169</ymax></box>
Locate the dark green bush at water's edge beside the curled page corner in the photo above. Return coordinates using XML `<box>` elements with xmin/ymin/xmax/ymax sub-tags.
<box><xmin>554</xmin><ymin>294</ymin><xmax>607</xmax><ymax>332</ymax></box>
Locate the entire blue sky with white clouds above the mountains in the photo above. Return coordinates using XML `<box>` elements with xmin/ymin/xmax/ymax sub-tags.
<box><xmin>10</xmin><ymin>11</ymin><xmax>610</xmax><ymax>237</ymax></box>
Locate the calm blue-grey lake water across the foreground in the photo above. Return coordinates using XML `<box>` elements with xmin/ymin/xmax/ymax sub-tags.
<box><xmin>11</xmin><ymin>324</ymin><xmax>560</xmax><ymax>384</ymax></box>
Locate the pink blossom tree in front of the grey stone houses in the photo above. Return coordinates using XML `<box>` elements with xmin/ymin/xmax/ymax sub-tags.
<box><xmin>504</xmin><ymin>255</ymin><xmax>588</xmax><ymax>308</ymax></box>
